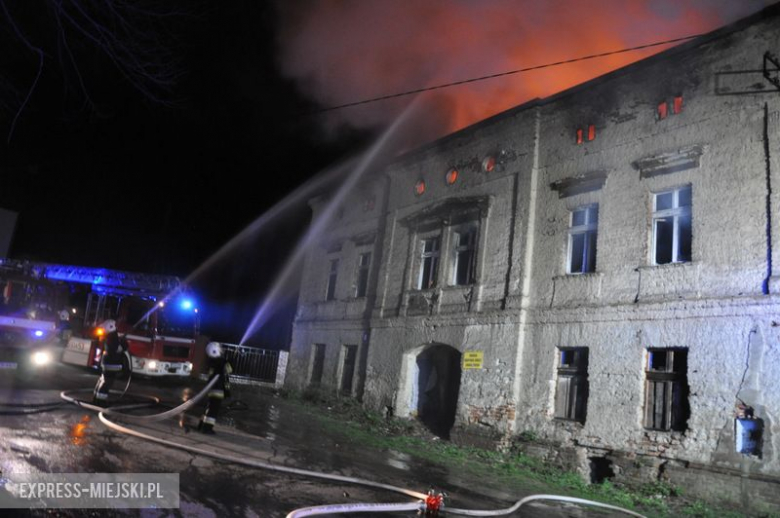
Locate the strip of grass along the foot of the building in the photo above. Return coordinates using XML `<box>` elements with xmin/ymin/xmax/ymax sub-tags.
<box><xmin>280</xmin><ymin>391</ymin><xmax>768</xmax><ymax>518</ymax></box>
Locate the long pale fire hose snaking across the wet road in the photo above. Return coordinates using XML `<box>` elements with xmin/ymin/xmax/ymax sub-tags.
<box><xmin>60</xmin><ymin>376</ymin><xmax>645</xmax><ymax>518</ymax></box>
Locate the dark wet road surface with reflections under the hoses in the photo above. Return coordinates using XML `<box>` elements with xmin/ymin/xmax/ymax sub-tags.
<box><xmin>0</xmin><ymin>366</ymin><xmax>624</xmax><ymax>517</ymax></box>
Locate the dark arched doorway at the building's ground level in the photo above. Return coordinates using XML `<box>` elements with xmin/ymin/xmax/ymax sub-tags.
<box><xmin>413</xmin><ymin>344</ymin><xmax>461</xmax><ymax>439</ymax></box>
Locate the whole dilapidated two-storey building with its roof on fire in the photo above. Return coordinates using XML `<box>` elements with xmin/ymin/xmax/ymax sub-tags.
<box><xmin>288</xmin><ymin>7</ymin><xmax>780</xmax><ymax>505</ymax></box>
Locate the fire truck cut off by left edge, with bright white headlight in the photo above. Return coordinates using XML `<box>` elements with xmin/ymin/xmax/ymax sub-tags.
<box><xmin>0</xmin><ymin>259</ymin><xmax>71</xmax><ymax>371</ymax></box>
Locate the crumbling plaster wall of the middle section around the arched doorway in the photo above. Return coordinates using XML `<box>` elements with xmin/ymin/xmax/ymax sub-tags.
<box><xmin>365</xmin><ymin>111</ymin><xmax>535</xmax><ymax>434</ymax></box>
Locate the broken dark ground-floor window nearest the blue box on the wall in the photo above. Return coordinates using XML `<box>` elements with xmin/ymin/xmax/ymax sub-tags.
<box><xmin>645</xmin><ymin>349</ymin><xmax>690</xmax><ymax>431</ymax></box>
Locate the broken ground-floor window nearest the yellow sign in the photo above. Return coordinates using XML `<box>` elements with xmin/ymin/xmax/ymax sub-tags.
<box><xmin>555</xmin><ymin>347</ymin><xmax>588</xmax><ymax>423</ymax></box>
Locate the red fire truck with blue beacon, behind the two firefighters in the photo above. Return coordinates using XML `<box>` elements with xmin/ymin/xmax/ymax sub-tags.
<box><xmin>46</xmin><ymin>265</ymin><xmax>200</xmax><ymax>377</ymax></box>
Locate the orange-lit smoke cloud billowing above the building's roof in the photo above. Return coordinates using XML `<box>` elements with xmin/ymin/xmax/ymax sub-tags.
<box><xmin>277</xmin><ymin>0</ymin><xmax>773</xmax><ymax>143</ymax></box>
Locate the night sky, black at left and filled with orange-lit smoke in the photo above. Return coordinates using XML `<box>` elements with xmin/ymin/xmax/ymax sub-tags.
<box><xmin>0</xmin><ymin>0</ymin><xmax>772</xmax><ymax>348</ymax></box>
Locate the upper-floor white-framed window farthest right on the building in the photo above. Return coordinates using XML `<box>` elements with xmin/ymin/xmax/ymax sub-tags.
<box><xmin>653</xmin><ymin>185</ymin><xmax>692</xmax><ymax>264</ymax></box>
